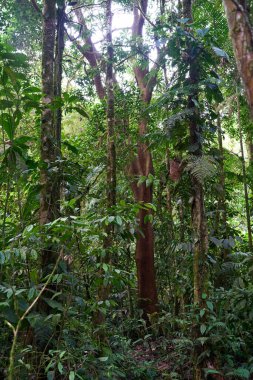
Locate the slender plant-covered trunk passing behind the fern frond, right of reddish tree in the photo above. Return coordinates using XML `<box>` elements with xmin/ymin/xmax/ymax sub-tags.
<box><xmin>183</xmin><ymin>0</ymin><xmax>208</xmax><ymax>380</ymax></box>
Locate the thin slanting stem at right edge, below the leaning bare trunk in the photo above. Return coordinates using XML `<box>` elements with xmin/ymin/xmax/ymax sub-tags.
<box><xmin>237</xmin><ymin>95</ymin><xmax>253</xmax><ymax>252</ymax></box>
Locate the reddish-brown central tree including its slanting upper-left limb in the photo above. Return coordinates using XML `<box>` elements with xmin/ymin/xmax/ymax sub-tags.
<box><xmin>69</xmin><ymin>0</ymin><xmax>157</xmax><ymax>316</ymax></box>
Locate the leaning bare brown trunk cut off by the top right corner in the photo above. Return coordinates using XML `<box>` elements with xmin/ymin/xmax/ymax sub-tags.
<box><xmin>223</xmin><ymin>0</ymin><xmax>253</xmax><ymax>116</ymax></box>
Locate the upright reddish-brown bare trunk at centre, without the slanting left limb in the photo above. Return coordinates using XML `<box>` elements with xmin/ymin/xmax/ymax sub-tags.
<box><xmin>130</xmin><ymin>0</ymin><xmax>158</xmax><ymax>320</ymax></box>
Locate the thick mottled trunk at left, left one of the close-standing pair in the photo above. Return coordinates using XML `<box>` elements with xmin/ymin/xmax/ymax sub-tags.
<box><xmin>39</xmin><ymin>0</ymin><xmax>57</xmax><ymax>269</ymax></box>
